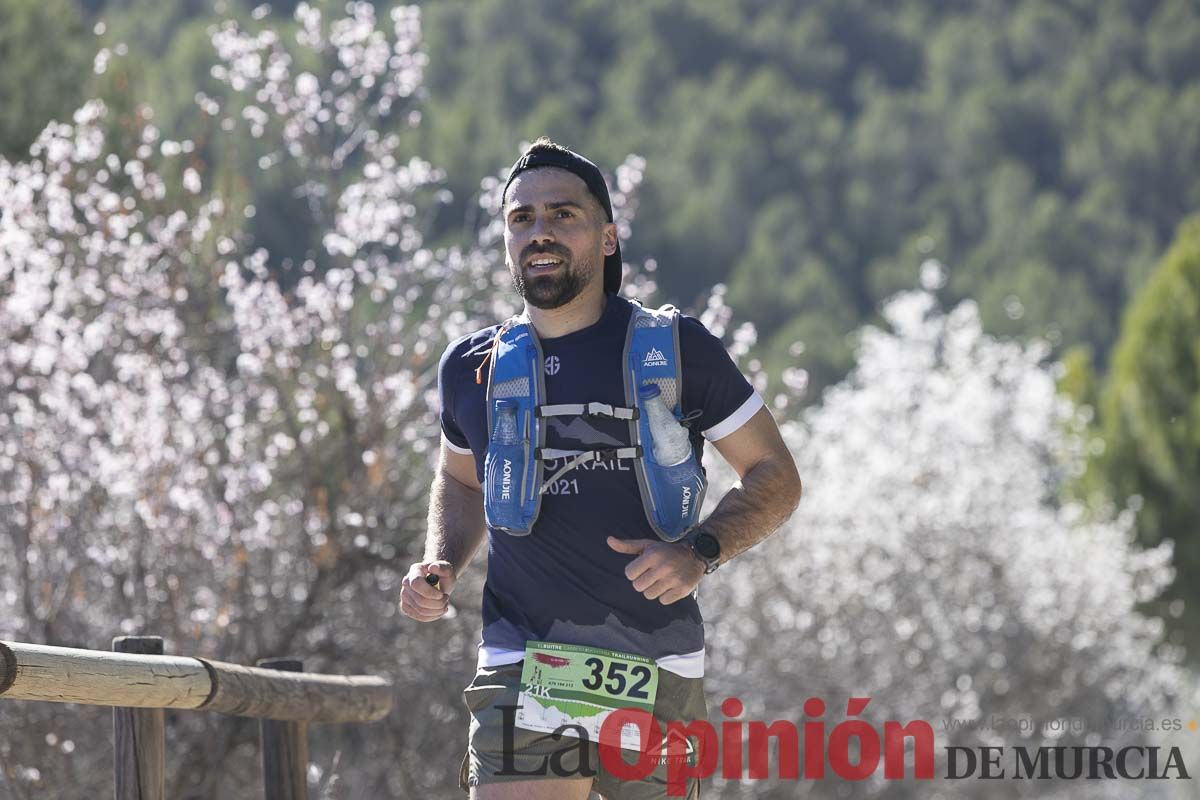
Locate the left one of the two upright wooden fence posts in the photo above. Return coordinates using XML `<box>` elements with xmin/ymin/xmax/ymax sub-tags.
<box><xmin>113</xmin><ymin>636</ymin><xmax>167</xmax><ymax>800</ymax></box>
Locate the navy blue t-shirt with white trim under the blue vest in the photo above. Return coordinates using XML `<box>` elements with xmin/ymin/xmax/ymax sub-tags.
<box><xmin>438</xmin><ymin>295</ymin><xmax>762</xmax><ymax>676</ymax></box>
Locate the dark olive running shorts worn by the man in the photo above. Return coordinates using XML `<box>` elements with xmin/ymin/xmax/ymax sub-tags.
<box><xmin>458</xmin><ymin>662</ymin><xmax>708</xmax><ymax>800</ymax></box>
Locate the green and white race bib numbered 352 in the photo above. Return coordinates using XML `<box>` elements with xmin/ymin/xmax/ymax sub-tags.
<box><xmin>516</xmin><ymin>642</ymin><xmax>659</xmax><ymax>751</ymax></box>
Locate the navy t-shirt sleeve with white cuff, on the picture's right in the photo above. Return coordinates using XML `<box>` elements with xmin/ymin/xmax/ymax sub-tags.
<box><xmin>679</xmin><ymin>317</ymin><xmax>763</xmax><ymax>441</ymax></box>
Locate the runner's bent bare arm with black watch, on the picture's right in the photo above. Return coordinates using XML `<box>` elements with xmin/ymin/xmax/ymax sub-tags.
<box><xmin>608</xmin><ymin>407</ymin><xmax>802</xmax><ymax>604</ymax></box>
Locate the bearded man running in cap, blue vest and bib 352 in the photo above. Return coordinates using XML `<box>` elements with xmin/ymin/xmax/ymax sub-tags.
<box><xmin>400</xmin><ymin>139</ymin><xmax>800</xmax><ymax>800</ymax></box>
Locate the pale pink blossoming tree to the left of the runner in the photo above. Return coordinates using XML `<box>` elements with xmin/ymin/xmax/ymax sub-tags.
<box><xmin>0</xmin><ymin>2</ymin><xmax>653</xmax><ymax>798</ymax></box>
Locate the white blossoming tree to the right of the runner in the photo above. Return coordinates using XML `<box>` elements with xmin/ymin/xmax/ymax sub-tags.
<box><xmin>701</xmin><ymin>273</ymin><xmax>1190</xmax><ymax>798</ymax></box>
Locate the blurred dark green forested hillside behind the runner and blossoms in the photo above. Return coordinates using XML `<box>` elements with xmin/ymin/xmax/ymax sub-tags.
<box><xmin>9</xmin><ymin>0</ymin><xmax>1200</xmax><ymax>396</ymax></box>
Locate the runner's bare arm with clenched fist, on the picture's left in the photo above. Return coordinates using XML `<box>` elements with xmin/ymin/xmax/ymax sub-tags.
<box><xmin>400</xmin><ymin>441</ymin><xmax>486</xmax><ymax>622</ymax></box>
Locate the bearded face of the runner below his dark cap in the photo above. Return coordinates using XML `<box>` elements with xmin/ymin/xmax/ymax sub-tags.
<box><xmin>504</xmin><ymin>167</ymin><xmax>617</xmax><ymax>308</ymax></box>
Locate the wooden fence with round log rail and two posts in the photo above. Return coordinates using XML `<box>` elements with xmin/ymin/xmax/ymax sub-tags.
<box><xmin>0</xmin><ymin>636</ymin><xmax>391</xmax><ymax>800</ymax></box>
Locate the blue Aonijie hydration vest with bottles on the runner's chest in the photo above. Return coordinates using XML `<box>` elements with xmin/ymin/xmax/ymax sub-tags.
<box><xmin>476</xmin><ymin>302</ymin><xmax>707</xmax><ymax>542</ymax></box>
